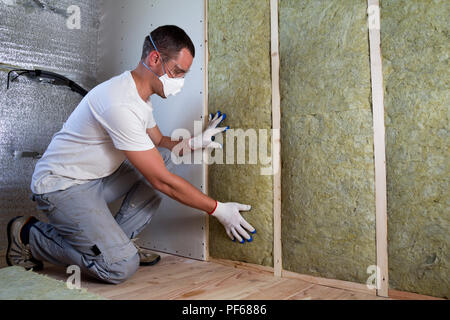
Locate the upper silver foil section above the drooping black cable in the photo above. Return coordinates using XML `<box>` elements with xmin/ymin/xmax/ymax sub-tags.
<box><xmin>0</xmin><ymin>0</ymin><xmax>99</xmax><ymax>88</ymax></box>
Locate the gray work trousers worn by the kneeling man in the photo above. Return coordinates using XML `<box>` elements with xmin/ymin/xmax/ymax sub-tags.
<box><xmin>30</xmin><ymin>150</ymin><xmax>173</xmax><ymax>284</ymax></box>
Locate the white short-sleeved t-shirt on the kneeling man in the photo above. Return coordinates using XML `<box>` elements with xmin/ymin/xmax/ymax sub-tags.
<box><xmin>31</xmin><ymin>71</ymin><xmax>156</xmax><ymax>194</ymax></box>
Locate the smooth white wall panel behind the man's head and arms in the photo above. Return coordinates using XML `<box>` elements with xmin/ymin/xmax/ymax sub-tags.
<box><xmin>98</xmin><ymin>0</ymin><xmax>206</xmax><ymax>260</ymax></box>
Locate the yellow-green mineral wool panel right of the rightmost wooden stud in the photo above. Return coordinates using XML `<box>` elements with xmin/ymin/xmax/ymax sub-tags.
<box><xmin>381</xmin><ymin>0</ymin><xmax>450</xmax><ymax>298</ymax></box>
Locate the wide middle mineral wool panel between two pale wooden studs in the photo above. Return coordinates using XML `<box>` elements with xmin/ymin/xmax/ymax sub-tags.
<box><xmin>279</xmin><ymin>0</ymin><xmax>376</xmax><ymax>283</ymax></box>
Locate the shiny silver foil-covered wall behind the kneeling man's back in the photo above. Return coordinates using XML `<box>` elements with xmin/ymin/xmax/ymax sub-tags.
<box><xmin>0</xmin><ymin>0</ymin><xmax>99</xmax><ymax>250</ymax></box>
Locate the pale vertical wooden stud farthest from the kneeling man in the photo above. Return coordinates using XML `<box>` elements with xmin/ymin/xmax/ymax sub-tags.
<box><xmin>368</xmin><ymin>0</ymin><xmax>389</xmax><ymax>297</ymax></box>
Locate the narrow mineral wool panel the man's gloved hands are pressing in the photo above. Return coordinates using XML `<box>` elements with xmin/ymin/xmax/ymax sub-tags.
<box><xmin>208</xmin><ymin>0</ymin><xmax>273</xmax><ymax>266</ymax></box>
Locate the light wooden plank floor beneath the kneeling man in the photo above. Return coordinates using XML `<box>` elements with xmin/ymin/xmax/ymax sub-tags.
<box><xmin>7</xmin><ymin>254</ymin><xmax>383</xmax><ymax>300</ymax></box>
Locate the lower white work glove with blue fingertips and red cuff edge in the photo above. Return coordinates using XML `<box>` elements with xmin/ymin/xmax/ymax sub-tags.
<box><xmin>210</xmin><ymin>202</ymin><xmax>256</xmax><ymax>243</ymax></box>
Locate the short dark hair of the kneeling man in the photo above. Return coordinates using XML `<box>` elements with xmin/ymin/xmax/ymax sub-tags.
<box><xmin>141</xmin><ymin>26</ymin><xmax>195</xmax><ymax>60</ymax></box>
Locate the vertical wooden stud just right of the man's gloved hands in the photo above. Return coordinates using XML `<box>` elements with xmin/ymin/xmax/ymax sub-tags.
<box><xmin>270</xmin><ymin>0</ymin><xmax>283</xmax><ymax>277</ymax></box>
